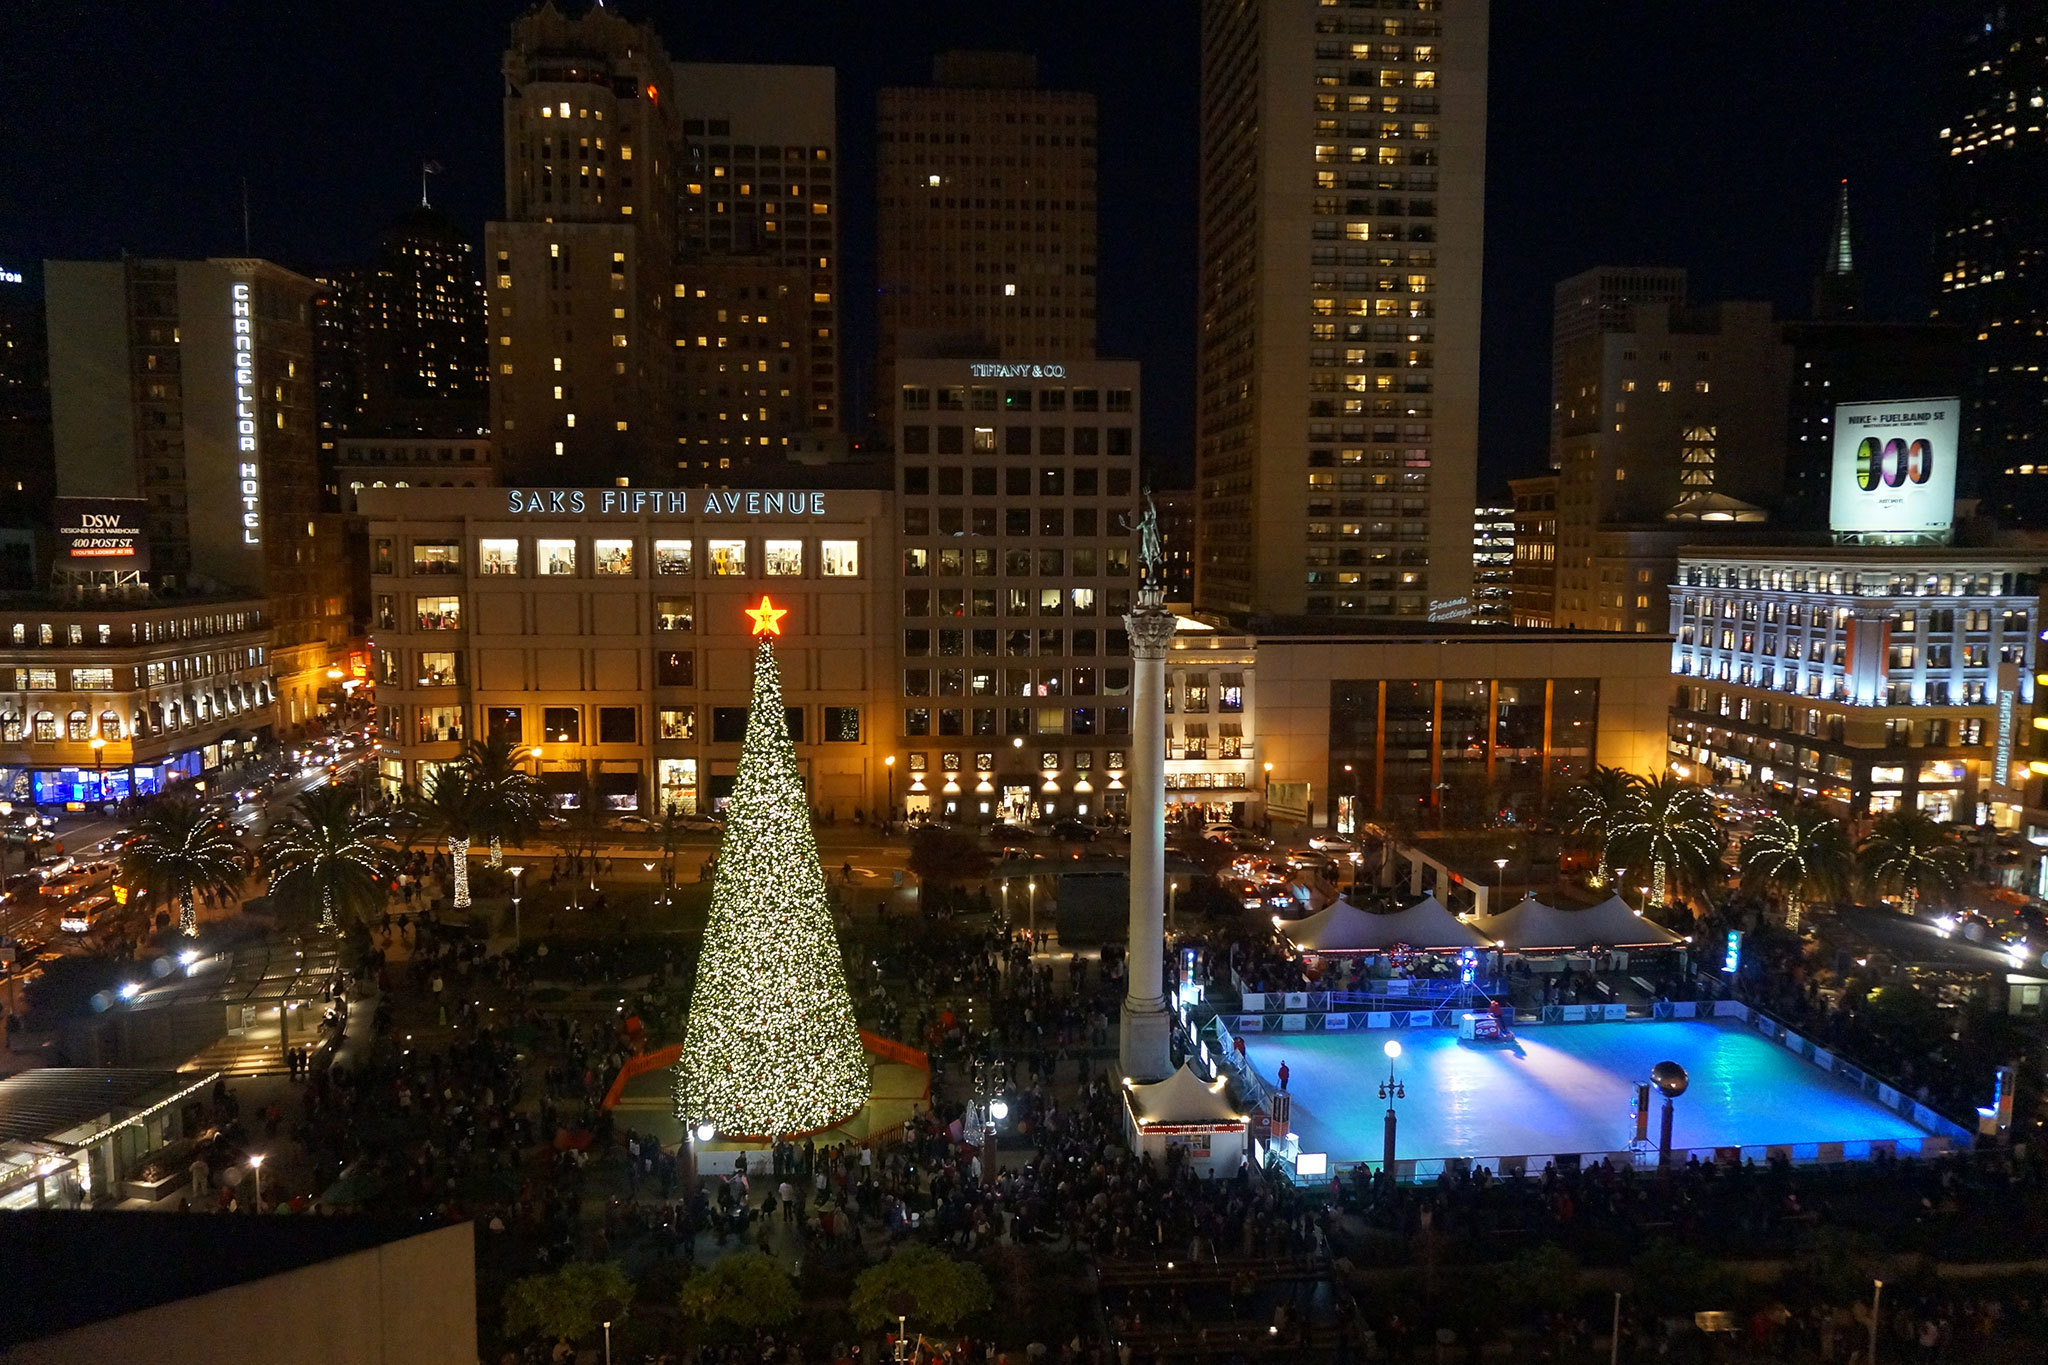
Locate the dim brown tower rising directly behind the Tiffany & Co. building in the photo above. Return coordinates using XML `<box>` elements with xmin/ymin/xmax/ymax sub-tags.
<box><xmin>874</xmin><ymin>51</ymin><xmax>1096</xmax><ymax>427</ymax></box>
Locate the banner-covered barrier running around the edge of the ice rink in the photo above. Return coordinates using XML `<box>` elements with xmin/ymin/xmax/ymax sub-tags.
<box><xmin>1212</xmin><ymin>993</ymin><xmax>1976</xmax><ymax>1183</ymax></box>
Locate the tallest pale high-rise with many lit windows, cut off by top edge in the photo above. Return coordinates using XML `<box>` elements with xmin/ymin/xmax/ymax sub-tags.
<box><xmin>1196</xmin><ymin>0</ymin><xmax>1487</xmax><ymax>618</ymax></box>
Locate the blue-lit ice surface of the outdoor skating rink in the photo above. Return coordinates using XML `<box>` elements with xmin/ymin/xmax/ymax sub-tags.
<box><xmin>1245</xmin><ymin>1019</ymin><xmax>1927</xmax><ymax>1164</ymax></box>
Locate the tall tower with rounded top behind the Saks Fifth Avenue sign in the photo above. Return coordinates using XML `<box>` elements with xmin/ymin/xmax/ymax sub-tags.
<box><xmin>483</xmin><ymin>4</ymin><xmax>678</xmax><ymax>485</ymax></box>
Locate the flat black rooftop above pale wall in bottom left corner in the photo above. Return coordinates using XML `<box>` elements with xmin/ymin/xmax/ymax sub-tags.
<box><xmin>0</xmin><ymin>1209</ymin><xmax>444</xmax><ymax>1349</ymax></box>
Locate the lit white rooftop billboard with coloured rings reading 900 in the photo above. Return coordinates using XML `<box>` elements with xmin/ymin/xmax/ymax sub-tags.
<box><xmin>1827</xmin><ymin>399</ymin><xmax>1962</xmax><ymax>534</ymax></box>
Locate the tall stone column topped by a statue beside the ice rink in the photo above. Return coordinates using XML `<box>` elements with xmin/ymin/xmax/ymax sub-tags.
<box><xmin>1120</xmin><ymin>493</ymin><xmax>1180</xmax><ymax>1081</ymax></box>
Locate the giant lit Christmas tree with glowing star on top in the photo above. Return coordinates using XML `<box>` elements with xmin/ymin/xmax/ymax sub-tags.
<box><xmin>676</xmin><ymin>598</ymin><xmax>868</xmax><ymax>1138</ymax></box>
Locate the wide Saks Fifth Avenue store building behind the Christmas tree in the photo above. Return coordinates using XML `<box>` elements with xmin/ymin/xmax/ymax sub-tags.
<box><xmin>358</xmin><ymin>487</ymin><xmax>895</xmax><ymax>819</ymax></box>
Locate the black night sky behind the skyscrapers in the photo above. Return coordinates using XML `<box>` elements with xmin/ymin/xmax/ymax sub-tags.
<box><xmin>0</xmin><ymin>0</ymin><xmax>1954</xmax><ymax>497</ymax></box>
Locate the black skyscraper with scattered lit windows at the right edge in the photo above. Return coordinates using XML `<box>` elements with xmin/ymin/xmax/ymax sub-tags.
<box><xmin>1933</xmin><ymin>0</ymin><xmax>2048</xmax><ymax>526</ymax></box>
